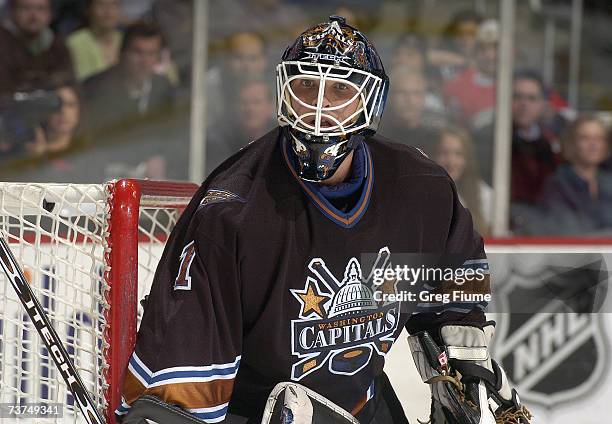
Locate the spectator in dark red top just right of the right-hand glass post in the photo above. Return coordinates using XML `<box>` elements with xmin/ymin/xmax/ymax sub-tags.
<box><xmin>510</xmin><ymin>71</ymin><xmax>557</xmax><ymax>204</ymax></box>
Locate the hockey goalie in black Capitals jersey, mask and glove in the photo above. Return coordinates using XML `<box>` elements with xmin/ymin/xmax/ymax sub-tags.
<box><xmin>116</xmin><ymin>16</ymin><xmax>531</xmax><ymax>424</ymax></box>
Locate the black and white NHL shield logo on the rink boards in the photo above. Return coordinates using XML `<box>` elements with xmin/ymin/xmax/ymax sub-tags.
<box><xmin>493</xmin><ymin>261</ymin><xmax>608</xmax><ymax>407</ymax></box>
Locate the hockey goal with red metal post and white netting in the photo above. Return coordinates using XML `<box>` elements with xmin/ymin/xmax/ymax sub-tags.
<box><xmin>0</xmin><ymin>180</ymin><xmax>197</xmax><ymax>423</ymax></box>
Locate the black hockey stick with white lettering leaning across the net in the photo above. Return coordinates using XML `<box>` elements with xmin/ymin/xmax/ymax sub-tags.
<box><xmin>0</xmin><ymin>236</ymin><xmax>104</xmax><ymax>424</ymax></box>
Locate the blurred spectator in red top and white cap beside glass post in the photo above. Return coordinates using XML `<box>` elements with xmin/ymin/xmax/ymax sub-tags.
<box><xmin>444</xmin><ymin>19</ymin><xmax>499</xmax><ymax>130</ymax></box>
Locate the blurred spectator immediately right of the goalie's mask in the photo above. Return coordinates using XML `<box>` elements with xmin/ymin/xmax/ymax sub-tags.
<box><xmin>382</xmin><ymin>68</ymin><xmax>443</xmax><ymax>155</ymax></box>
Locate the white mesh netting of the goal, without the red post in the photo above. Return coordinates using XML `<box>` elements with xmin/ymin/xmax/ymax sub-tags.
<box><xmin>0</xmin><ymin>183</ymin><xmax>194</xmax><ymax>423</ymax></box>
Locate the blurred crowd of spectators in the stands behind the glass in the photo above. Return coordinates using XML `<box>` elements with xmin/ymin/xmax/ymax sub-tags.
<box><xmin>0</xmin><ymin>0</ymin><xmax>612</xmax><ymax>235</ymax></box>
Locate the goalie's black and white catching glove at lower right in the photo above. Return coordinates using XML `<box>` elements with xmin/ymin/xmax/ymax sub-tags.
<box><xmin>408</xmin><ymin>321</ymin><xmax>532</xmax><ymax>424</ymax></box>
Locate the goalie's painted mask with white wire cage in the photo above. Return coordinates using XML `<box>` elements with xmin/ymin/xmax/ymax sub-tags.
<box><xmin>276</xmin><ymin>16</ymin><xmax>389</xmax><ymax>181</ymax></box>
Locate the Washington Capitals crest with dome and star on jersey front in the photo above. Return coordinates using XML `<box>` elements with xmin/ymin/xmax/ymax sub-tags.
<box><xmin>291</xmin><ymin>247</ymin><xmax>400</xmax><ymax>381</ymax></box>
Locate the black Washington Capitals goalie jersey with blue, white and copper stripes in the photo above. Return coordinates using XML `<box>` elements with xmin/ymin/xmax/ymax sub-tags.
<box><xmin>116</xmin><ymin>128</ymin><xmax>489</xmax><ymax>423</ymax></box>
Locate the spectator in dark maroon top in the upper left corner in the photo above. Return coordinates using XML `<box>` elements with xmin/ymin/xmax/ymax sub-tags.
<box><xmin>0</xmin><ymin>0</ymin><xmax>74</xmax><ymax>96</ymax></box>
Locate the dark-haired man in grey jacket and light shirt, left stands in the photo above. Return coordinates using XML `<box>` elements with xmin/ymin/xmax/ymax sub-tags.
<box><xmin>84</xmin><ymin>21</ymin><xmax>173</xmax><ymax>136</ymax></box>
